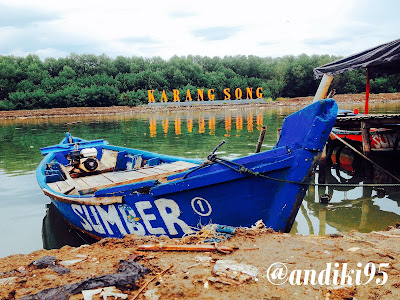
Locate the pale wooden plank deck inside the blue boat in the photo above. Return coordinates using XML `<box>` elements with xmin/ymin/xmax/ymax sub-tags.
<box><xmin>47</xmin><ymin>161</ymin><xmax>198</xmax><ymax>195</ymax></box>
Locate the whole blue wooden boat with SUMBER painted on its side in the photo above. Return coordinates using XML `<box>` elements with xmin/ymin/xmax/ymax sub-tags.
<box><xmin>36</xmin><ymin>99</ymin><xmax>337</xmax><ymax>238</ymax></box>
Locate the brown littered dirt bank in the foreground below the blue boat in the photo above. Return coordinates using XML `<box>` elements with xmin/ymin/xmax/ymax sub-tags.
<box><xmin>0</xmin><ymin>223</ymin><xmax>400</xmax><ymax>300</ymax></box>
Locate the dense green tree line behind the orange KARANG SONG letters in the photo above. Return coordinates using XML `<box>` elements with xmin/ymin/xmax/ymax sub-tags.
<box><xmin>0</xmin><ymin>54</ymin><xmax>400</xmax><ymax>110</ymax></box>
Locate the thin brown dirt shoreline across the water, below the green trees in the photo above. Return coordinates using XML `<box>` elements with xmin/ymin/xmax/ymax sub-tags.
<box><xmin>0</xmin><ymin>92</ymin><xmax>400</xmax><ymax>119</ymax></box>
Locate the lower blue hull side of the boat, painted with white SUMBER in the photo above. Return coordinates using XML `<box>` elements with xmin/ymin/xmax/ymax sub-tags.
<box><xmin>46</xmin><ymin>152</ymin><xmax>312</xmax><ymax>237</ymax></box>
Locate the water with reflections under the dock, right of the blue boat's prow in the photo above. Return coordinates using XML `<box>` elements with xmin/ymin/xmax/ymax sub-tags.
<box><xmin>292</xmin><ymin>158</ymin><xmax>400</xmax><ymax>235</ymax></box>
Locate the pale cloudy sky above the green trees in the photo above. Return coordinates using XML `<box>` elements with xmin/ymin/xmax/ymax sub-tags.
<box><xmin>0</xmin><ymin>0</ymin><xmax>400</xmax><ymax>59</ymax></box>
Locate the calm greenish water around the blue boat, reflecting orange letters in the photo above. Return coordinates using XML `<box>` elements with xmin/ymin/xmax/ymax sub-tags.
<box><xmin>0</xmin><ymin>105</ymin><xmax>400</xmax><ymax>257</ymax></box>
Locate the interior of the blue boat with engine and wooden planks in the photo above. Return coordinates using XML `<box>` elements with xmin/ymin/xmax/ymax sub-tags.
<box><xmin>44</xmin><ymin>147</ymin><xmax>198</xmax><ymax>196</ymax></box>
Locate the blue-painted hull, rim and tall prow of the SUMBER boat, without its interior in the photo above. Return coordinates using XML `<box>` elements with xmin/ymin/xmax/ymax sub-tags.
<box><xmin>37</xmin><ymin>99</ymin><xmax>337</xmax><ymax>237</ymax></box>
